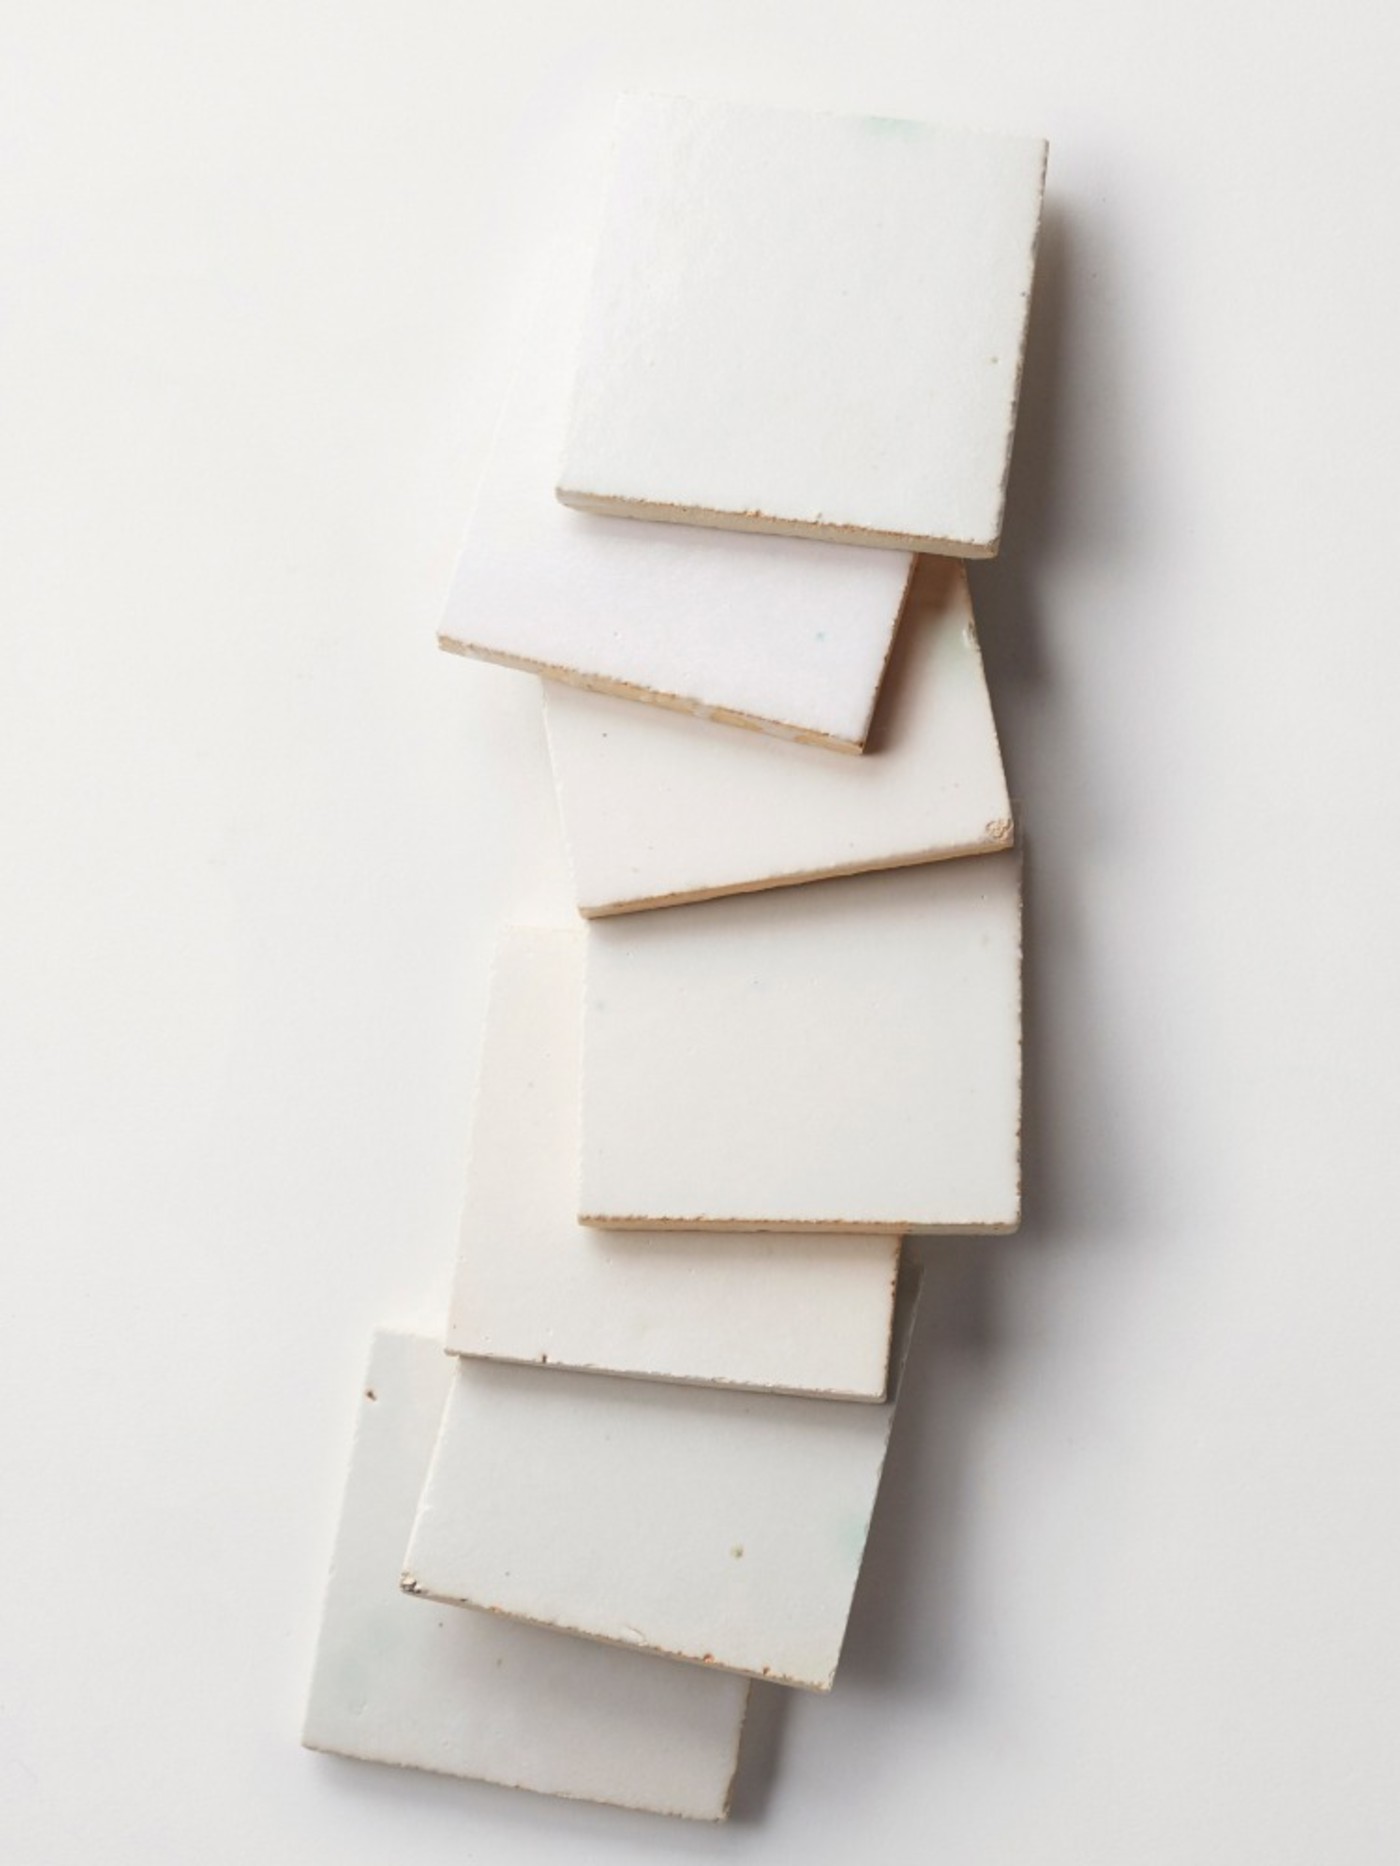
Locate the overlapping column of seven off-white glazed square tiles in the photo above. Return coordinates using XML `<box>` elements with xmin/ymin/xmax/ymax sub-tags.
<box><xmin>304</xmin><ymin>97</ymin><xmax>1045</xmax><ymax>1819</ymax></box>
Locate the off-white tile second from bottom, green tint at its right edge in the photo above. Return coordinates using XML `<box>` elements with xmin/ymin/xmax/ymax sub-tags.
<box><xmin>405</xmin><ymin>1304</ymin><xmax>907</xmax><ymax>1691</ymax></box>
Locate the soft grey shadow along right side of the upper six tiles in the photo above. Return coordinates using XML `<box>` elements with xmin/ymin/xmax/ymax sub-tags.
<box><xmin>838</xmin><ymin>196</ymin><xmax>1133</xmax><ymax>1696</ymax></box>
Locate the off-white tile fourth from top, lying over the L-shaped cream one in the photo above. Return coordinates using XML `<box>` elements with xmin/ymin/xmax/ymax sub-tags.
<box><xmin>581</xmin><ymin>853</ymin><xmax>1021</xmax><ymax>1232</ymax></box>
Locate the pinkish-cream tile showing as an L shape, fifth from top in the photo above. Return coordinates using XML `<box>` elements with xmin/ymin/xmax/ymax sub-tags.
<box><xmin>455</xmin><ymin>925</ymin><xmax>900</xmax><ymax>1400</ymax></box>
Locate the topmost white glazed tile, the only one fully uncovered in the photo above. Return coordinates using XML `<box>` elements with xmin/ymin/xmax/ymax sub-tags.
<box><xmin>558</xmin><ymin>97</ymin><xmax>1045</xmax><ymax>558</ymax></box>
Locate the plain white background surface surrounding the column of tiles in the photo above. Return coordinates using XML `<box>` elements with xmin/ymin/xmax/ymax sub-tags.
<box><xmin>0</xmin><ymin>0</ymin><xmax>1400</xmax><ymax>1866</ymax></box>
